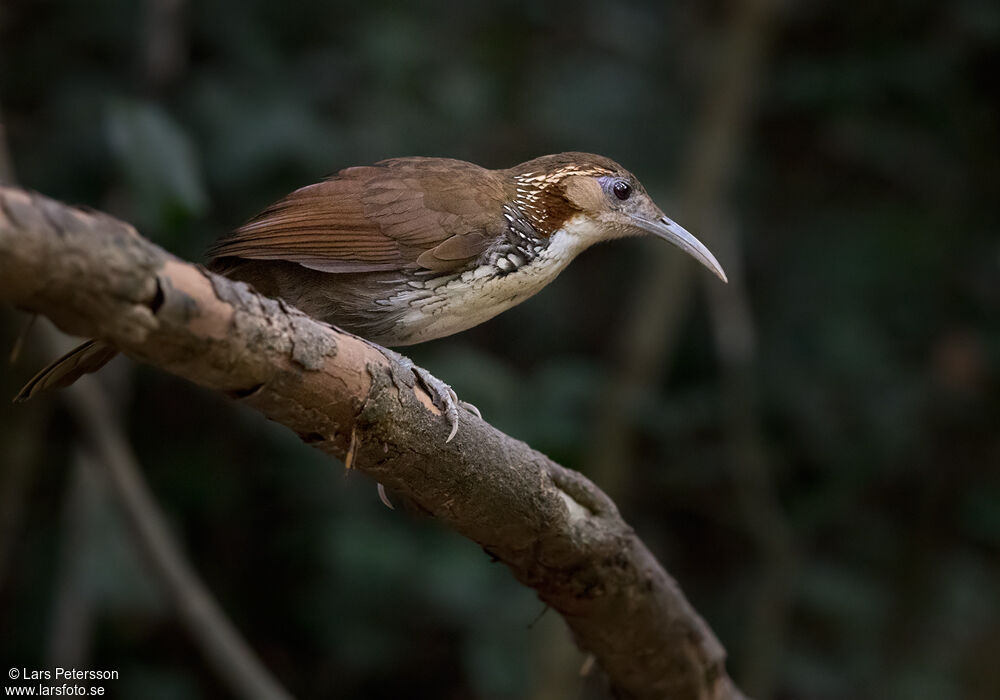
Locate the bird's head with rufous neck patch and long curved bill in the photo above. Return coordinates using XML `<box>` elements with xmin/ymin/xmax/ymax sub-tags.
<box><xmin>508</xmin><ymin>153</ymin><xmax>728</xmax><ymax>282</ymax></box>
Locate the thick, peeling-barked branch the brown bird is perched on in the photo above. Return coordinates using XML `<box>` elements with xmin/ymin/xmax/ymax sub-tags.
<box><xmin>0</xmin><ymin>188</ymin><xmax>741</xmax><ymax>698</ymax></box>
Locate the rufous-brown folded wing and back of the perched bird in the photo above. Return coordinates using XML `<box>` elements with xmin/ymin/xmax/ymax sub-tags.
<box><xmin>210</xmin><ymin>158</ymin><xmax>505</xmax><ymax>272</ymax></box>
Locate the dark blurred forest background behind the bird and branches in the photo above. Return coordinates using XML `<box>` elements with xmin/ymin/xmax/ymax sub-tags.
<box><xmin>0</xmin><ymin>0</ymin><xmax>1000</xmax><ymax>700</ymax></box>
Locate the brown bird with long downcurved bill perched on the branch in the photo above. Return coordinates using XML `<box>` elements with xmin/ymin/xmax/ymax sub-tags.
<box><xmin>15</xmin><ymin>152</ymin><xmax>727</xmax><ymax>440</ymax></box>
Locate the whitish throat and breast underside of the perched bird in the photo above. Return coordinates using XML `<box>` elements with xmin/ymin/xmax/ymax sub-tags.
<box><xmin>386</xmin><ymin>217</ymin><xmax>607</xmax><ymax>343</ymax></box>
